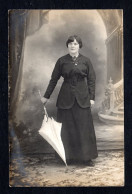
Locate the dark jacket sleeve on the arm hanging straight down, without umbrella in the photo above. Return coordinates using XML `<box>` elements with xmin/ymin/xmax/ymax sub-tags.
<box><xmin>87</xmin><ymin>59</ymin><xmax>96</xmax><ymax>100</ymax></box>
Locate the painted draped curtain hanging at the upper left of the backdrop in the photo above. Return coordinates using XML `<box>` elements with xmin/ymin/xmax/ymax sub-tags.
<box><xmin>8</xmin><ymin>10</ymin><xmax>49</xmax><ymax>118</ymax></box>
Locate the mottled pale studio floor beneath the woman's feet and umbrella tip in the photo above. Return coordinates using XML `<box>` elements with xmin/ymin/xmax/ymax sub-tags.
<box><xmin>9</xmin><ymin>150</ymin><xmax>124</xmax><ymax>187</ymax></box>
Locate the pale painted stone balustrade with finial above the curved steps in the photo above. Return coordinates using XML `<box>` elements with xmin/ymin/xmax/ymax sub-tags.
<box><xmin>101</xmin><ymin>78</ymin><xmax>123</xmax><ymax>113</ymax></box>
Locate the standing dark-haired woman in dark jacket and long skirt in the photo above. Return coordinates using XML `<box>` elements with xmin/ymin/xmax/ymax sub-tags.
<box><xmin>41</xmin><ymin>35</ymin><xmax>98</xmax><ymax>166</ymax></box>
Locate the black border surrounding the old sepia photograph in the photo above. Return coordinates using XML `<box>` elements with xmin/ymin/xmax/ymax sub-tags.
<box><xmin>0</xmin><ymin>1</ymin><xmax>132</xmax><ymax>193</ymax></box>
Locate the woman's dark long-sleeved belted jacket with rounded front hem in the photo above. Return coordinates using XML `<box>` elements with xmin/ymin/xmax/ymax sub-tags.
<box><xmin>44</xmin><ymin>54</ymin><xmax>95</xmax><ymax>109</ymax></box>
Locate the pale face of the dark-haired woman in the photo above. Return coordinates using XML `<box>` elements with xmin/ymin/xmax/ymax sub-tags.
<box><xmin>68</xmin><ymin>39</ymin><xmax>79</xmax><ymax>54</ymax></box>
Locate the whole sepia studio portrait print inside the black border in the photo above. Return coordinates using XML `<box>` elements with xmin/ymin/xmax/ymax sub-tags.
<box><xmin>8</xmin><ymin>9</ymin><xmax>125</xmax><ymax>187</ymax></box>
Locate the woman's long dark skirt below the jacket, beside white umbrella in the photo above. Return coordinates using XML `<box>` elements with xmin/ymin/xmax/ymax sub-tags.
<box><xmin>57</xmin><ymin>100</ymin><xmax>98</xmax><ymax>162</ymax></box>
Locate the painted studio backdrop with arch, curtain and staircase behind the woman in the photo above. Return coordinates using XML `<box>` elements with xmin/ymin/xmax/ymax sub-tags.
<box><xmin>9</xmin><ymin>10</ymin><xmax>124</xmax><ymax>157</ymax></box>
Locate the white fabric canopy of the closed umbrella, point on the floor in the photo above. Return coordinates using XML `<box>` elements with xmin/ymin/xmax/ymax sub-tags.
<box><xmin>39</xmin><ymin>109</ymin><xmax>67</xmax><ymax>166</ymax></box>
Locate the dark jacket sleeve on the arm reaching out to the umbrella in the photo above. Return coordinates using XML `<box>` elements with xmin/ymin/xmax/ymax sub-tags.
<box><xmin>44</xmin><ymin>59</ymin><xmax>61</xmax><ymax>99</ymax></box>
